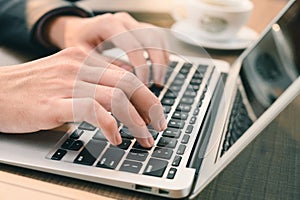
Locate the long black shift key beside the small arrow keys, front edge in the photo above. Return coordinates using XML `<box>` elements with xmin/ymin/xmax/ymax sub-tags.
<box><xmin>74</xmin><ymin>140</ymin><xmax>107</xmax><ymax>165</ymax></box>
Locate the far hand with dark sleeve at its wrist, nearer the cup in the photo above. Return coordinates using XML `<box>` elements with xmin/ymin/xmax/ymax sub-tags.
<box><xmin>48</xmin><ymin>13</ymin><xmax>168</xmax><ymax>85</ymax></box>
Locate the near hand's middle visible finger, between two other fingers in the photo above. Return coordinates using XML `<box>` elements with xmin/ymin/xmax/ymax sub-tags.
<box><xmin>71</xmin><ymin>81</ymin><xmax>154</xmax><ymax>147</ymax></box>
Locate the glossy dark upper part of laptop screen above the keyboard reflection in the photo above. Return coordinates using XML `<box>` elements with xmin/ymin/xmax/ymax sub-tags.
<box><xmin>240</xmin><ymin>1</ymin><xmax>300</xmax><ymax>118</ymax></box>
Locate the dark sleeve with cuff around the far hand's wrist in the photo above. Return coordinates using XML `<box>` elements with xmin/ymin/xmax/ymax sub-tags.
<box><xmin>0</xmin><ymin>0</ymin><xmax>92</xmax><ymax>52</ymax></box>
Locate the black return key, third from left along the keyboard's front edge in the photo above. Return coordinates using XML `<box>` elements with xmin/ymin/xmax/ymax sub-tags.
<box><xmin>97</xmin><ymin>148</ymin><xmax>125</xmax><ymax>169</ymax></box>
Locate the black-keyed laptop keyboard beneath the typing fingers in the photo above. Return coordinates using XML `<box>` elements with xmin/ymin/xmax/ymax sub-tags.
<box><xmin>48</xmin><ymin>62</ymin><xmax>213</xmax><ymax>179</ymax></box>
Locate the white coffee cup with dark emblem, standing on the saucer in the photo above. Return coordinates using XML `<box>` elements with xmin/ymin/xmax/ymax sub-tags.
<box><xmin>172</xmin><ymin>0</ymin><xmax>253</xmax><ymax>41</ymax></box>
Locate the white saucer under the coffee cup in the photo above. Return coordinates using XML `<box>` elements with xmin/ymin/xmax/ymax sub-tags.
<box><xmin>171</xmin><ymin>21</ymin><xmax>258</xmax><ymax>50</ymax></box>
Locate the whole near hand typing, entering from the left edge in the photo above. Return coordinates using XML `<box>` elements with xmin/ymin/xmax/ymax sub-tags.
<box><xmin>0</xmin><ymin>48</ymin><xmax>166</xmax><ymax>147</ymax></box>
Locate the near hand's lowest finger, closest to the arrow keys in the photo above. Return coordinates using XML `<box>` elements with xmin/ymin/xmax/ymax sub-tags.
<box><xmin>57</xmin><ymin>98</ymin><xmax>122</xmax><ymax>145</ymax></box>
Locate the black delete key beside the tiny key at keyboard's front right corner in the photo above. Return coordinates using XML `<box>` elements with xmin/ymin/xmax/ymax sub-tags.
<box><xmin>143</xmin><ymin>158</ymin><xmax>168</xmax><ymax>177</ymax></box>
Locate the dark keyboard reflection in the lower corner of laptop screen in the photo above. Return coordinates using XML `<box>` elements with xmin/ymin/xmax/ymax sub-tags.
<box><xmin>221</xmin><ymin>89</ymin><xmax>253</xmax><ymax>156</ymax></box>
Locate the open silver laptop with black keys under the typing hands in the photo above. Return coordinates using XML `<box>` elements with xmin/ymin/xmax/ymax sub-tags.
<box><xmin>0</xmin><ymin>1</ymin><xmax>300</xmax><ymax>199</ymax></box>
